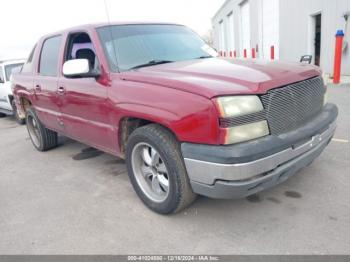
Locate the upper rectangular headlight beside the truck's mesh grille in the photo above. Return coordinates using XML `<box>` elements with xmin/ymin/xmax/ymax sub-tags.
<box><xmin>216</xmin><ymin>96</ymin><xmax>264</xmax><ymax>117</ymax></box>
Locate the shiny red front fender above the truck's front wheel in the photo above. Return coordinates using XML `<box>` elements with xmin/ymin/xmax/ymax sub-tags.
<box><xmin>109</xmin><ymin>81</ymin><xmax>219</xmax><ymax>144</ymax></box>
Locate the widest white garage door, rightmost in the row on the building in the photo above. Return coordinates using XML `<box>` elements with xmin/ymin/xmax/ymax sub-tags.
<box><xmin>261</xmin><ymin>0</ymin><xmax>279</xmax><ymax>59</ymax></box>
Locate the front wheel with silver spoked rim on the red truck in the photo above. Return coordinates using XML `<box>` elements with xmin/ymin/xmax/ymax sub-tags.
<box><xmin>126</xmin><ymin>124</ymin><xmax>196</xmax><ymax>214</ymax></box>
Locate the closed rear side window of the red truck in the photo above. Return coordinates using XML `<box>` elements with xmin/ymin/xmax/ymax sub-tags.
<box><xmin>39</xmin><ymin>36</ymin><xmax>62</xmax><ymax>76</ymax></box>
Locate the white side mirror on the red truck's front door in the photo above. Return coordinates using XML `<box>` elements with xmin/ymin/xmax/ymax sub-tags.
<box><xmin>63</xmin><ymin>59</ymin><xmax>100</xmax><ymax>77</ymax></box>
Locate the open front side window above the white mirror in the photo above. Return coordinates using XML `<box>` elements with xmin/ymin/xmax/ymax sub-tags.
<box><xmin>64</xmin><ymin>32</ymin><xmax>100</xmax><ymax>70</ymax></box>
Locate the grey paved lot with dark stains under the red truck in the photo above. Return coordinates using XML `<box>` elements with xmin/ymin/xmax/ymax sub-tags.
<box><xmin>0</xmin><ymin>85</ymin><xmax>350</xmax><ymax>254</ymax></box>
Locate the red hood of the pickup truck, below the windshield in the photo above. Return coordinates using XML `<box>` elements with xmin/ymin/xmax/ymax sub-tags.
<box><xmin>119</xmin><ymin>58</ymin><xmax>321</xmax><ymax>98</ymax></box>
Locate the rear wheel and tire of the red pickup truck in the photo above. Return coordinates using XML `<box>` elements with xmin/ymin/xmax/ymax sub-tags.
<box><xmin>26</xmin><ymin>107</ymin><xmax>58</xmax><ymax>152</ymax></box>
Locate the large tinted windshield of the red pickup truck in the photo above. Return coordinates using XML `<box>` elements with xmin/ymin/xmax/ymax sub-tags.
<box><xmin>97</xmin><ymin>25</ymin><xmax>217</xmax><ymax>72</ymax></box>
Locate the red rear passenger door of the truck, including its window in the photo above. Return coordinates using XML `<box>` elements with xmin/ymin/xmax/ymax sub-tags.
<box><xmin>32</xmin><ymin>35</ymin><xmax>63</xmax><ymax>131</ymax></box>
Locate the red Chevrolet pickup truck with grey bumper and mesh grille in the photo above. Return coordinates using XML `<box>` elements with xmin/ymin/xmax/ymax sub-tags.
<box><xmin>13</xmin><ymin>23</ymin><xmax>338</xmax><ymax>214</ymax></box>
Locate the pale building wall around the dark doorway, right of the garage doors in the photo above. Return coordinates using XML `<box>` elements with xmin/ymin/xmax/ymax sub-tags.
<box><xmin>280</xmin><ymin>0</ymin><xmax>350</xmax><ymax>75</ymax></box>
